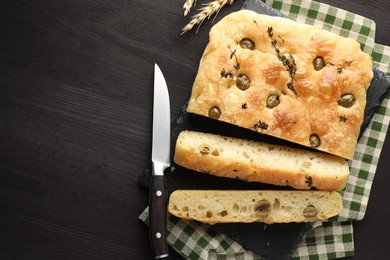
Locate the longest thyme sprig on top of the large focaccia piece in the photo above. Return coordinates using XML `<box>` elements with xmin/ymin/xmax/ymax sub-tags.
<box><xmin>267</xmin><ymin>27</ymin><xmax>298</xmax><ymax>95</ymax></box>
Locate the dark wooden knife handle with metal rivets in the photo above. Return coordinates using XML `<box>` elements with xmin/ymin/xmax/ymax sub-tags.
<box><xmin>149</xmin><ymin>175</ymin><xmax>168</xmax><ymax>259</ymax></box>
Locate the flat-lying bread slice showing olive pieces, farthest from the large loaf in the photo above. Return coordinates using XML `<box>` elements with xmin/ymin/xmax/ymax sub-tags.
<box><xmin>168</xmin><ymin>190</ymin><xmax>343</xmax><ymax>224</ymax></box>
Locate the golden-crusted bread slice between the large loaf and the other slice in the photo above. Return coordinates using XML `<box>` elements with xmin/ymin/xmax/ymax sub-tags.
<box><xmin>174</xmin><ymin>131</ymin><xmax>349</xmax><ymax>191</ymax></box>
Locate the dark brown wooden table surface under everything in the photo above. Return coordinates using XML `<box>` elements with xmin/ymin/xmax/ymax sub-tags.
<box><xmin>0</xmin><ymin>0</ymin><xmax>390</xmax><ymax>259</ymax></box>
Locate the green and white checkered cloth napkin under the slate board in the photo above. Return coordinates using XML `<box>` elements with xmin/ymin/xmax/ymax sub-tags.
<box><xmin>139</xmin><ymin>0</ymin><xmax>390</xmax><ymax>259</ymax></box>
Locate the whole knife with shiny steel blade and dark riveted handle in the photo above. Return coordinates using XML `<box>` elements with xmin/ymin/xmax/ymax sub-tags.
<box><xmin>149</xmin><ymin>64</ymin><xmax>171</xmax><ymax>259</ymax></box>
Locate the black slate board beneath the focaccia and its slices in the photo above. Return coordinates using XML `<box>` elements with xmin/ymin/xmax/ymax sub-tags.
<box><xmin>139</xmin><ymin>0</ymin><xmax>390</xmax><ymax>259</ymax></box>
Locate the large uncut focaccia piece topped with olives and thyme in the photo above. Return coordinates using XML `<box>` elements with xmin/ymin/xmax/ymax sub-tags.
<box><xmin>187</xmin><ymin>10</ymin><xmax>373</xmax><ymax>159</ymax></box>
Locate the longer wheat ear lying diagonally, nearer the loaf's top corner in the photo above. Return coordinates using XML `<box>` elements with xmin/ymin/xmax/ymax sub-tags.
<box><xmin>182</xmin><ymin>0</ymin><xmax>234</xmax><ymax>34</ymax></box>
